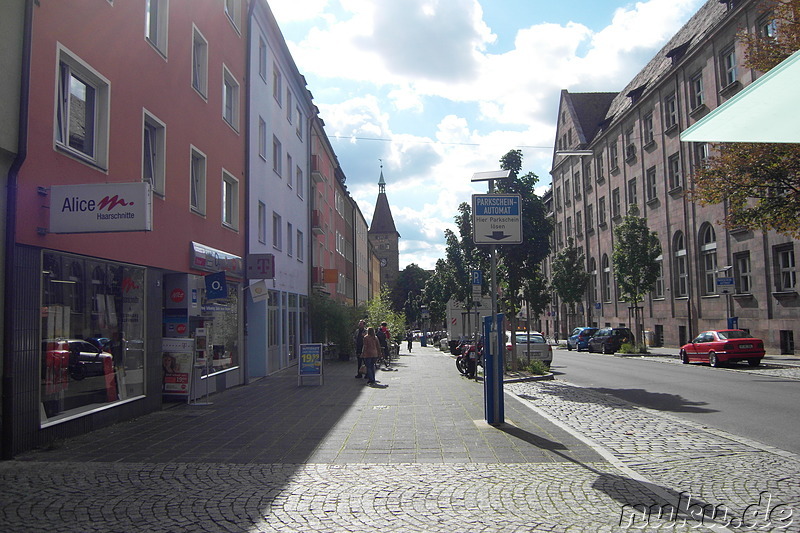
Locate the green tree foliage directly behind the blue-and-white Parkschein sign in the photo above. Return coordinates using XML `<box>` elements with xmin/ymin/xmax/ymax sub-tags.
<box><xmin>490</xmin><ymin>150</ymin><xmax>552</xmax><ymax>340</ymax></box>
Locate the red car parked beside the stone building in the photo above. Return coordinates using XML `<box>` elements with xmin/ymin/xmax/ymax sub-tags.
<box><xmin>681</xmin><ymin>329</ymin><xmax>764</xmax><ymax>367</ymax></box>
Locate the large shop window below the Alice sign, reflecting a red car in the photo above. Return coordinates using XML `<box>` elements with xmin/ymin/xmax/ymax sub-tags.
<box><xmin>40</xmin><ymin>252</ymin><xmax>145</xmax><ymax>426</ymax></box>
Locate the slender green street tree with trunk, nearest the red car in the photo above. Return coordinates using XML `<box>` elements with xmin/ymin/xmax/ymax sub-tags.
<box><xmin>611</xmin><ymin>204</ymin><xmax>661</xmax><ymax>350</ymax></box>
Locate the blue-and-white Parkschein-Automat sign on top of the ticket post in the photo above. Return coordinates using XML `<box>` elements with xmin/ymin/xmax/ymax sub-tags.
<box><xmin>472</xmin><ymin>194</ymin><xmax>522</xmax><ymax>244</ymax></box>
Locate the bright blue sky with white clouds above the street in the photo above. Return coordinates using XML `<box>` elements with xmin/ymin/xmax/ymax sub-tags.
<box><xmin>268</xmin><ymin>0</ymin><xmax>706</xmax><ymax>270</ymax></box>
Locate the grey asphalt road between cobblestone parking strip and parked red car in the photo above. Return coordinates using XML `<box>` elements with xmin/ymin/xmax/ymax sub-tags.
<box><xmin>551</xmin><ymin>349</ymin><xmax>800</xmax><ymax>453</ymax></box>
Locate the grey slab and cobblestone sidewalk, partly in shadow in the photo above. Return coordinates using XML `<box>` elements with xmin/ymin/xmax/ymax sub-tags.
<box><xmin>0</xmin><ymin>346</ymin><xmax>800</xmax><ymax>533</ymax></box>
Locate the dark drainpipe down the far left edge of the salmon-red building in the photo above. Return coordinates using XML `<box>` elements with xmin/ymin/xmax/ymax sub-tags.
<box><xmin>0</xmin><ymin>0</ymin><xmax>35</xmax><ymax>459</ymax></box>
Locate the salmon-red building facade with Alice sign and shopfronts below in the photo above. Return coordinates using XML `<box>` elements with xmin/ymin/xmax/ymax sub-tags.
<box><xmin>4</xmin><ymin>0</ymin><xmax>247</xmax><ymax>454</ymax></box>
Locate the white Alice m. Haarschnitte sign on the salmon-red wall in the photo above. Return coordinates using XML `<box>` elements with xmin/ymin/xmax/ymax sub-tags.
<box><xmin>50</xmin><ymin>181</ymin><xmax>153</xmax><ymax>233</ymax></box>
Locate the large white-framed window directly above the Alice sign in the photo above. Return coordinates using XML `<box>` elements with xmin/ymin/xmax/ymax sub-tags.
<box><xmin>55</xmin><ymin>49</ymin><xmax>109</xmax><ymax>168</ymax></box>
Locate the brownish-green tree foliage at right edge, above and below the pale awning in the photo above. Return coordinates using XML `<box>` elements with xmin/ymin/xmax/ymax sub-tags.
<box><xmin>689</xmin><ymin>0</ymin><xmax>800</xmax><ymax>238</ymax></box>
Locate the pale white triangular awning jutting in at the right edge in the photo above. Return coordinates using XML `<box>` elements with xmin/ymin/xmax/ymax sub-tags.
<box><xmin>681</xmin><ymin>47</ymin><xmax>800</xmax><ymax>143</ymax></box>
